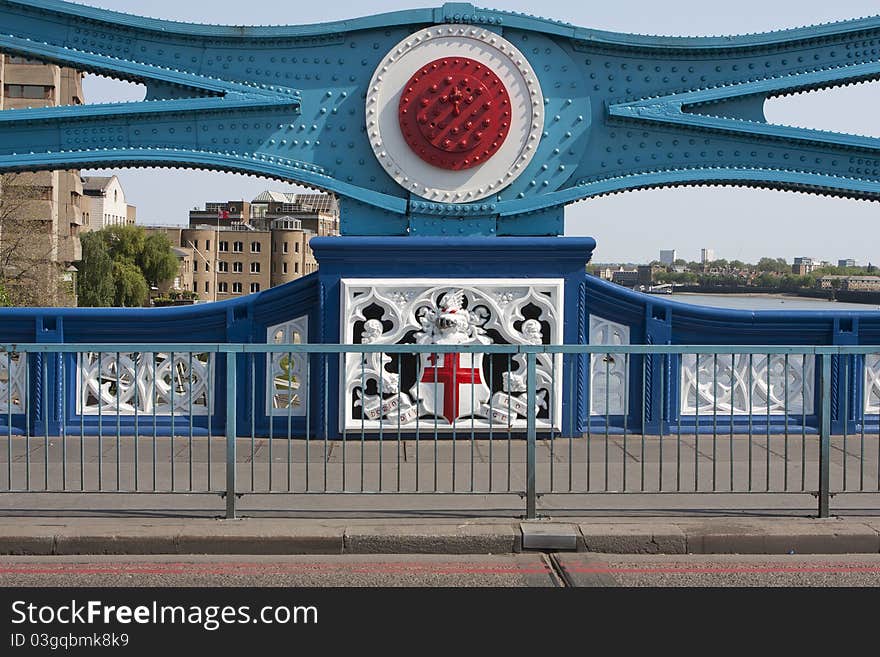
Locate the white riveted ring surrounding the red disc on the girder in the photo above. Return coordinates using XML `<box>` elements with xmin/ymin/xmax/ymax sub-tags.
<box><xmin>366</xmin><ymin>25</ymin><xmax>544</xmax><ymax>203</ymax></box>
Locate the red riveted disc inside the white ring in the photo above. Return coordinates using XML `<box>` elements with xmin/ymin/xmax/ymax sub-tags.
<box><xmin>398</xmin><ymin>57</ymin><xmax>510</xmax><ymax>171</ymax></box>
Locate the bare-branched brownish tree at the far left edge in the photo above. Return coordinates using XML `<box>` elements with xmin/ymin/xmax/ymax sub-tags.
<box><xmin>0</xmin><ymin>173</ymin><xmax>61</xmax><ymax>306</ymax></box>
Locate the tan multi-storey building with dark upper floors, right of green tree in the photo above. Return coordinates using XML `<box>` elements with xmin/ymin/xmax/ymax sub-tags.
<box><xmin>147</xmin><ymin>192</ymin><xmax>339</xmax><ymax>301</ymax></box>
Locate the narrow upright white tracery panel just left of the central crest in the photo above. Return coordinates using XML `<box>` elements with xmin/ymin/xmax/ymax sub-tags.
<box><xmin>266</xmin><ymin>316</ymin><xmax>309</xmax><ymax>416</ymax></box>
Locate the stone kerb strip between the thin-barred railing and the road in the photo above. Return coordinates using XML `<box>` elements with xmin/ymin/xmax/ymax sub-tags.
<box><xmin>0</xmin><ymin>516</ymin><xmax>880</xmax><ymax>555</ymax></box>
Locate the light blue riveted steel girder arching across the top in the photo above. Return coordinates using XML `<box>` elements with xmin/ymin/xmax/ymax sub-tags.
<box><xmin>0</xmin><ymin>0</ymin><xmax>880</xmax><ymax>235</ymax></box>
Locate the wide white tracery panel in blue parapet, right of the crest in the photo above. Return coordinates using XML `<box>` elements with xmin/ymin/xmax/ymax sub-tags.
<box><xmin>681</xmin><ymin>354</ymin><xmax>815</xmax><ymax>415</ymax></box>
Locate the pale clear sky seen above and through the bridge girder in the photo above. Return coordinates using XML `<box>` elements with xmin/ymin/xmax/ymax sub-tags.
<box><xmin>74</xmin><ymin>0</ymin><xmax>880</xmax><ymax>264</ymax></box>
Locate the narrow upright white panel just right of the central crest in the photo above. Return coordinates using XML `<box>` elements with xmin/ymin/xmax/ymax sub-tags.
<box><xmin>590</xmin><ymin>315</ymin><xmax>630</xmax><ymax>415</ymax></box>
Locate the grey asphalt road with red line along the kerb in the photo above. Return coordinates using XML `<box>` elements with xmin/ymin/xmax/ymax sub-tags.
<box><xmin>0</xmin><ymin>553</ymin><xmax>880</xmax><ymax>587</ymax></box>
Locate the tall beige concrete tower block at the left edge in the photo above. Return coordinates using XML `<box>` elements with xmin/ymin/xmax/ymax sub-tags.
<box><xmin>0</xmin><ymin>54</ymin><xmax>83</xmax><ymax>305</ymax></box>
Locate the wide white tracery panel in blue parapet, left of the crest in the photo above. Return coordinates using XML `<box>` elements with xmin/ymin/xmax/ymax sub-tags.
<box><xmin>76</xmin><ymin>352</ymin><xmax>214</xmax><ymax>415</ymax></box>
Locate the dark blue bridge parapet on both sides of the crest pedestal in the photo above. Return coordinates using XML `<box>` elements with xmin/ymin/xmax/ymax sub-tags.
<box><xmin>0</xmin><ymin>275</ymin><xmax>880</xmax><ymax>435</ymax></box>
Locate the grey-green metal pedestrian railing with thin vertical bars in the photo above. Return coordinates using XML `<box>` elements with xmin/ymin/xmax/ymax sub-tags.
<box><xmin>0</xmin><ymin>343</ymin><xmax>880</xmax><ymax>517</ymax></box>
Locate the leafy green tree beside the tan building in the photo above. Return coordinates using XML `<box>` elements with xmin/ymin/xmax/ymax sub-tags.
<box><xmin>78</xmin><ymin>225</ymin><xmax>177</xmax><ymax>307</ymax></box>
